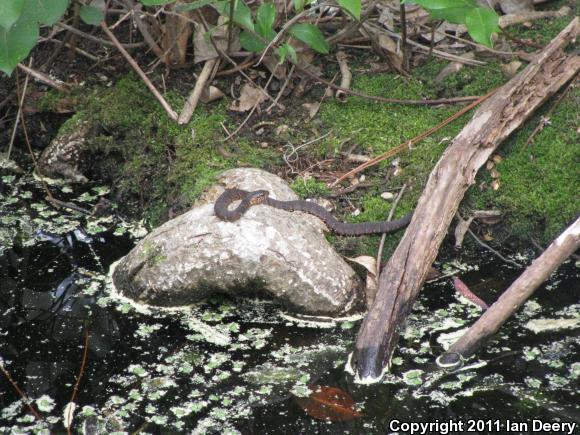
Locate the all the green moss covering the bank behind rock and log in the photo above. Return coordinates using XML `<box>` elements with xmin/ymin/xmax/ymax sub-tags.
<box><xmin>40</xmin><ymin>11</ymin><xmax>580</xmax><ymax>255</ymax></box>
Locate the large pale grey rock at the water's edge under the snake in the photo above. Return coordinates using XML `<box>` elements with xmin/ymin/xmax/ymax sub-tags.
<box><xmin>113</xmin><ymin>169</ymin><xmax>363</xmax><ymax>316</ymax></box>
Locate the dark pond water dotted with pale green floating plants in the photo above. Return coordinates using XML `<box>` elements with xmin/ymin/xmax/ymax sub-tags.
<box><xmin>0</xmin><ymin>172</ymin><xmax>580</xmax><ymax>434</ymax></box>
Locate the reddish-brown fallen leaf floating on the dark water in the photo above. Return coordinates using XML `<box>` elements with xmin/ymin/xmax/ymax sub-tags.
<box><xmin>296</xmin><ymin>385</ymin><xmax>362</xmax><ymax>421</ymax></box>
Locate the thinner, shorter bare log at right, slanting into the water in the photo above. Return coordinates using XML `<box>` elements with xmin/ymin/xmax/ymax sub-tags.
<box><xmin>447</xmin><ymin>217</ymin><xmax>580</xmax><ymax>358</ymax></box>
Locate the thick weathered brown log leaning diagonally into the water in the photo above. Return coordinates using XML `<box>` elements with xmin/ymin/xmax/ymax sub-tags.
<box><xmin>353</xmin><ymin>17</ymin><xmax>580</xmax><ymax>382</ymax></box>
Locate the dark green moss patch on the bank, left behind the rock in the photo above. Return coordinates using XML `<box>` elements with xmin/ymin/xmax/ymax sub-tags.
<box><xmin>57</xmin><ymin>75</ymin><xmax>276</xmax><ymax>226</ymax></box>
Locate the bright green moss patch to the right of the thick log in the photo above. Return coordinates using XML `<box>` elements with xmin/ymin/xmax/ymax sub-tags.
<box><xmin>467</xmin><ymin>89</ymin><xmax>580</xmax><ymax>243</ymax></box>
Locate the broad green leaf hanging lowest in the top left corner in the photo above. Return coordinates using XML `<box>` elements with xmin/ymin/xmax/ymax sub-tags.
<box><xmin>0</xmin><ymin>14</ymin><xmax>38</xmax><ymax>75</ymax></box>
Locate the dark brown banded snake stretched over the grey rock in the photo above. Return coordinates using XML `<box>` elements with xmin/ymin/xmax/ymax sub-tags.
<box><xmin>214</xmin><ymin>189</ymin><xmax>413</xmax><ymax>236</ymax></box>
